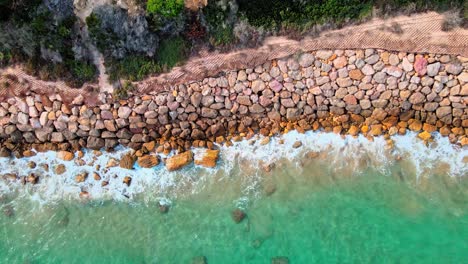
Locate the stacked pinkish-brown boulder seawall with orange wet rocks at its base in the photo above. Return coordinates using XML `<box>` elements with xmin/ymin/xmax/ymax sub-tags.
<box><xmin>0</xmin><ymin>49</ymin><xmax>468</xmax><ymax>170</ymax></box>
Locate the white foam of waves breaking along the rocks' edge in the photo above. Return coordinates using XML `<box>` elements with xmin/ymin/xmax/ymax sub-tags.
<box><xmin>0</xmin><ymin>131</ymin><xmax>468</xmax><ymax>203</ymax></box>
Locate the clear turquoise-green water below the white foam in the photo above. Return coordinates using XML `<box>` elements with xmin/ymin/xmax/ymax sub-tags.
<box><xmin>0</xmin><ymin>164</ymin><xmax>468</xmax><ymax>263</ymax></box>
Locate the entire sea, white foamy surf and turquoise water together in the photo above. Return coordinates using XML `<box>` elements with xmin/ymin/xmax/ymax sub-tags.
<box><xmin>0</xmin><ymin>133</ymin><xmax>468</xmax><ymax>263</ymax></box>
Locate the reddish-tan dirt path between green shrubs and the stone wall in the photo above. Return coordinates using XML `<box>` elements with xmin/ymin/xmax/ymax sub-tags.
<box><xmin>0</xmin><ymin>12</ymin><xmax>468</xmax><ymax>104</ymax></box>
